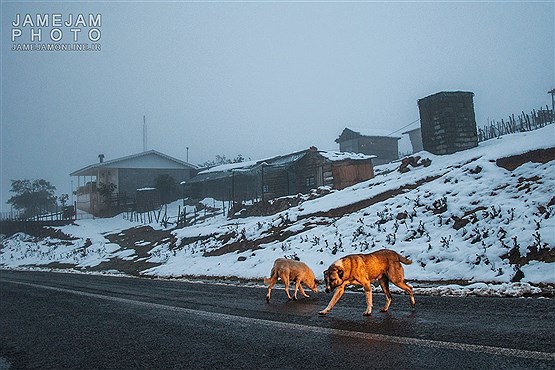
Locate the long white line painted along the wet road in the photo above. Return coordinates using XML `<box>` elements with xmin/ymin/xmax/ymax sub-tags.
<box><xmin>4</xmin><ymin>279</ymin><xmax>555</xmax><ymax>361</ymax></box>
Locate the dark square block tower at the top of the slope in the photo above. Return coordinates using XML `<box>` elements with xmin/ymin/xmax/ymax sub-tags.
<box><xmin>418</xmin><ymin>91</ymin><xmax>478</xmax><ymax>154</ymax></box>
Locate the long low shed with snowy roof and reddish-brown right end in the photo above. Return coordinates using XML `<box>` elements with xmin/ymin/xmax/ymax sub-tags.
<box><xmin>182</xmin><ymin>147</ymin><xmax>374</xmax><ymax>202</ymax></box>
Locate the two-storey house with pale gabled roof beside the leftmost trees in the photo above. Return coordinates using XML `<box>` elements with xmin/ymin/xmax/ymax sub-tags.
<box><xmin>70</xmin><ymin>150</ymin><xmax>197</xmax><ymax>216</ymax></box>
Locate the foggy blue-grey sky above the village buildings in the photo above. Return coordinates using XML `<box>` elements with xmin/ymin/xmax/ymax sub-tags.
<box><xmin>0</xmin><ymin>1</ymin><xmax>555</xmax><ymax>210</ymax></box>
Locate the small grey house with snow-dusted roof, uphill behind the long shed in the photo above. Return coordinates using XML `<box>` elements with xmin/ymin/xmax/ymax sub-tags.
<box><xmin>335</xmin><ymin>128</ymin><xmax>401</xmax><ymax>165</ymax></box>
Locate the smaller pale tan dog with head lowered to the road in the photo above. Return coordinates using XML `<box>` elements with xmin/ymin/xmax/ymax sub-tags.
<box><xmin>264</xmin><ymin>258</ymin><xmax>318</xmax><ymax>303</ymax></box>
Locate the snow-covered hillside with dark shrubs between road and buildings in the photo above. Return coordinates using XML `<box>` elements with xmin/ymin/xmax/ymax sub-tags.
<box><xmin>0</xmin><ymin>125</ymin><xmax>555</xmax><ymax>296</ymax></box>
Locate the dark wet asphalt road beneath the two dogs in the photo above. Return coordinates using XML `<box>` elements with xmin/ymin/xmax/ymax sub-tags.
<box><xmin>0</xmin><ymin>271</ymin><xmax>555</xmax><ymax>369</ymax></box>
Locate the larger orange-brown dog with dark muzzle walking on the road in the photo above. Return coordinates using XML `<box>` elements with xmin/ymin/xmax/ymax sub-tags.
<box><xmin>319</xmin><ymin>249</ymin><xmax>416</xmax><ymax>316</ymax></box>
